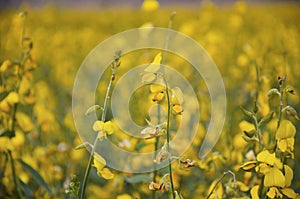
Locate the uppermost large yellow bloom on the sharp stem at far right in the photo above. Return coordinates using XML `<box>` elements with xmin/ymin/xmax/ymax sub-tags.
<box><xmin>276</xmin><ymin>120</ymin><xmax>296</xmax><ymax>153</ymax></box>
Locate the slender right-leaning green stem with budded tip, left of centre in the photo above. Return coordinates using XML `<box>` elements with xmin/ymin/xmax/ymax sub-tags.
<box><xmin>80</xmin><ymin>52</ymin><xmax>121</xmax><ymax>199</ymax></box>
